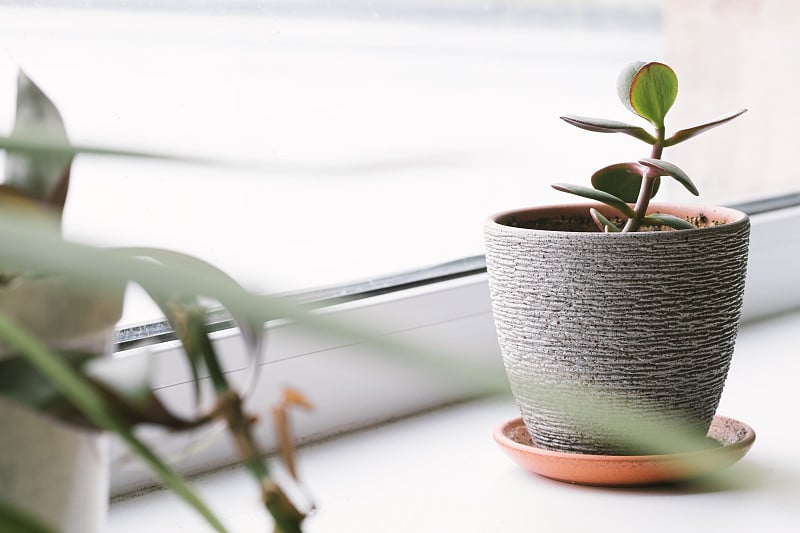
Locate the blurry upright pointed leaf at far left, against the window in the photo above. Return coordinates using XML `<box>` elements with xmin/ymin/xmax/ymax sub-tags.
<box><xmin>5</xmin><ymin>70</ymin><xmax>73</xmax><ymax>210</ymax></box>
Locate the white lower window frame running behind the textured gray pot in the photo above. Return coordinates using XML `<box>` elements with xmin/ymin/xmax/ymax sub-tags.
<box><xmin>112</xmin><ymin>195</ymin><xmax>800</xmax><ymax>495</ymax></box>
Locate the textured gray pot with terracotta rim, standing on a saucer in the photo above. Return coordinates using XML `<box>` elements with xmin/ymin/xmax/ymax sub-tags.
<box><xmin>485</xmin><ymin>204</ymin><xmax>750</xmax><ymax>455</ymax></box>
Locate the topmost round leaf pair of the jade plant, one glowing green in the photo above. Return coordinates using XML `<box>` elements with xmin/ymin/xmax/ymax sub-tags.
<box><xmin>617</xmin><ymin>61</ymin><xmax>678</xmax><ymax>128</ymax></box>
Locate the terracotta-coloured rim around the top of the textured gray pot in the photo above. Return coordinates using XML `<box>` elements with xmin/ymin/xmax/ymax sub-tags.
<box><xmin>486</xmin><ymin>202</ymin><xmax>749</xmax><ymax>238</ymax></box>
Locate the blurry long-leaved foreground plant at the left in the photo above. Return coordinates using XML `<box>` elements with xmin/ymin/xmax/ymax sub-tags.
<box><xmin>0</xmin><ymin>72</ymin><xmax>308</xmax><ymax>533</ymax></box>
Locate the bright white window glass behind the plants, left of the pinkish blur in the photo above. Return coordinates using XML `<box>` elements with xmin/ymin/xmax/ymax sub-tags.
<box><xmin>0</xmin><ymin>0</ymin><xmax>791</xmax><ymax>320</ymax></box>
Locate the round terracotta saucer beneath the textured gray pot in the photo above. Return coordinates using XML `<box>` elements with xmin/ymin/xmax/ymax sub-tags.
<box><xmin>494</xmin><ymin>415</ymin><xmax>756</xmax><ymax>486</ymax></box>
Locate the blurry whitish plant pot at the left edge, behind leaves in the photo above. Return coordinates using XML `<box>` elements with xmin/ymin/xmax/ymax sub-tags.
<box><xmin>0</xmin><ymin>277</ymin><xmax>122</xmax><ymax>533</ymax></box>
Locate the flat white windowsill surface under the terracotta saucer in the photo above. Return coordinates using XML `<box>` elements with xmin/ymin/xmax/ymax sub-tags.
<box><xmin>109</xmin><ymin>311</ymin><xmax>800</xmax><ymax>533</ymax></box>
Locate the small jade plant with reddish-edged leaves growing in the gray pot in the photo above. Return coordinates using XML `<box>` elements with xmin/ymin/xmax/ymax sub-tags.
<box><xmin>553</xmin><ymin>61</ymin><xmax>747</xmax><ymax>232</ymax></box>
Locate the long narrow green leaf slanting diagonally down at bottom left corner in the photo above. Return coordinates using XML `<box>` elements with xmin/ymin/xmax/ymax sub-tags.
<box><xmin>0</xmin><ymin>316</ymin><xmax>231</xmax><ymax>533</ymax></box>
